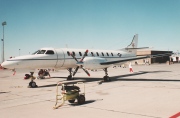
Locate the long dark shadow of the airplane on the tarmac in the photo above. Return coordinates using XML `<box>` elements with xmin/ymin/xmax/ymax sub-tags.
<box><xmin>38</xmin><ymin>71</ymin><xmax>180</xmax><ymax>88</ymax></box>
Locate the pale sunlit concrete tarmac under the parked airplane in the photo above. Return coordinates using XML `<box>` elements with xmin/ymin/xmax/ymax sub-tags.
<box><xmin>0</xmin><ymin>64</ymin><xmax>180</xmax><ymax>118</ymax></box>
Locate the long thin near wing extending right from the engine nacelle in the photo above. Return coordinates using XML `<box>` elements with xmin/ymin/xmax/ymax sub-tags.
<box><xmin>100</xmin><ymin>53</ymin><xmax>172</xmax><ymax>65</ymax></box>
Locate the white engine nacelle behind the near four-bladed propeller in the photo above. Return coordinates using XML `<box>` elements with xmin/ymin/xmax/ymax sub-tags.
<box><xmin>83</xmin><ymin>57</ymin><xmax>110</xmax><ymax>69</ymax></box>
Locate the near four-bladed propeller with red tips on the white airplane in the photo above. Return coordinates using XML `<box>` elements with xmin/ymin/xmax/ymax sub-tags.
<box><xmin>70</xmin><ymin>50</ymin><xmax>90</xmax><ymax>76</ymax></box>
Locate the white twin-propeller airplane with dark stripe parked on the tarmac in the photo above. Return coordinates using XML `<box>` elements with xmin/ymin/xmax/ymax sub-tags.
<box><xmin>1</xmin><ymin>34</ymin><xmax>170</xmax><ymax>88</ymax></box>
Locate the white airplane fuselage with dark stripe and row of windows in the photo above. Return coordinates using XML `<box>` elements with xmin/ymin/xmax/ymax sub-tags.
<box><xmin>2</xmin><ymin>48</ymin><xmax>136</xmax><ymax>69</ymax></box>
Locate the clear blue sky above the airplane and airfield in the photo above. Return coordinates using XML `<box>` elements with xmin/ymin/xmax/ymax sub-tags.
<box><xmin>0</xmin><ymin>0</ymin><xmax>180</xmax><ymax>62</ymax></box>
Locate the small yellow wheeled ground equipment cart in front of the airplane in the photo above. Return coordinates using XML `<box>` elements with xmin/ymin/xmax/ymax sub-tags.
<box><xmin>53</xmin><ymin>80</ymin><xmax>85</xmax><ymax>109</ymax></box>
